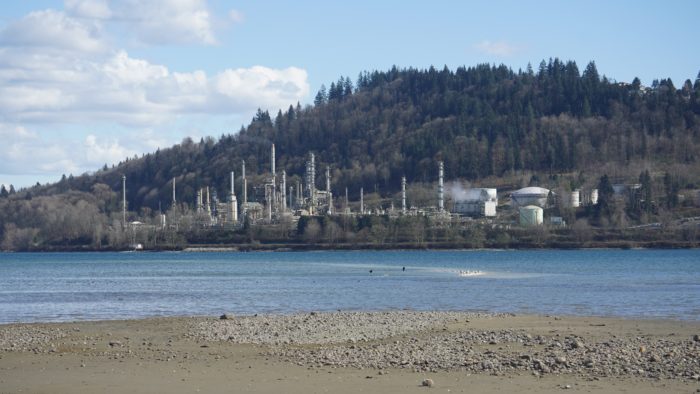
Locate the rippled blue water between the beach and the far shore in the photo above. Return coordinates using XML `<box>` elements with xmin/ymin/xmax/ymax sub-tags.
<box><xmin>0</xmin><ymin>250</ymin><xmax>700</xmax><ymax>323</ymax></box>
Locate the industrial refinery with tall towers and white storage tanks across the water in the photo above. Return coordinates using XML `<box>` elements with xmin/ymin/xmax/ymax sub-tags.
<box><xmin>122</xmin><ymin>144</ymin><xmax>598</xmax><ymax>229</ymax></box>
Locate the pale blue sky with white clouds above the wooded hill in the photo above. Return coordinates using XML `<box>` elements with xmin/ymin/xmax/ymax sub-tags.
<box><xmin>0</xmin><ymin>0</ymin><xmax>700</xmax><ymax>188</ymax></box>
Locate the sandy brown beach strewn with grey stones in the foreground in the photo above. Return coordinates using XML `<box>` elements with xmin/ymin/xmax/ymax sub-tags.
<box><xmin>0</xmin><ymin>311</ymin><xmax>700</xmax><ymax>393</ymax></box>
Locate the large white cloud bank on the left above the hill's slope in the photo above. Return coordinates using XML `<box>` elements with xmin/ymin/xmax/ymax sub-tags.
<box><xmin>0</xmin><ymin>0</ymin><xmax>309</xmax><ymax>185</ymax></box>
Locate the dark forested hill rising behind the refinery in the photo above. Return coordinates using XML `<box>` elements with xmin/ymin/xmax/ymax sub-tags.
<box><xmin>13</xmin><ymin>59</ymin><xmax>700</xmax><ymax>211</ymax></box>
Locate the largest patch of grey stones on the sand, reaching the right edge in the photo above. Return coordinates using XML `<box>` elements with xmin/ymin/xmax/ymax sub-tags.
<box><xmin>192</xmin><ymin>312</ymin><xmax>700</xmax><ymax>380</ymax></box>
